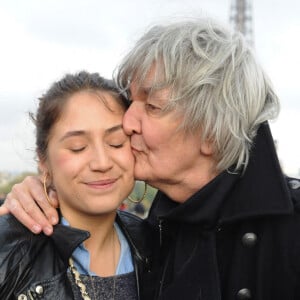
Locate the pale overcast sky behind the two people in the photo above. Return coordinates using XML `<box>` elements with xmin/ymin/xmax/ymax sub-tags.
<box><xmin>0</xmin><ymin>0</ymin><xmax>300</xmax><ymax>176</ymax></box>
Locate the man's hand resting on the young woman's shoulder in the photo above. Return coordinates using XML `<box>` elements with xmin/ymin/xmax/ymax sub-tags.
<box><xmin>0</xmin><ymin>176</ymin><xmax>58</xmax><ymax>235</ymax></box>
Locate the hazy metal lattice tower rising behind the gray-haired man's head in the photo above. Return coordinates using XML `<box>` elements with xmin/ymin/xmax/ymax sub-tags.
<box><xmin>229</xmin><ymin>0</ymin><xmax>254</xmax><ymax>46</ymax></box>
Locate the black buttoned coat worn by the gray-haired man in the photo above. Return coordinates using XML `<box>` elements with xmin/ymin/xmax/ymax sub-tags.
<box><xmin>148</xmin><ymin>124</ymin><xmax>300</xmax><ymax>300</ymax></box>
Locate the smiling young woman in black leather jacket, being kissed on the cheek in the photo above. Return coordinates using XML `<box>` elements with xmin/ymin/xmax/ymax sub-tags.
<box><xmin>0</xmin><ymin>72</ymin><xmax>150</xmax><ymax>300</ymax></box>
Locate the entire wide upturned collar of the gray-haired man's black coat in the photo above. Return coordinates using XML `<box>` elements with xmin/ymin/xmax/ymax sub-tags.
<box><xmin>149</xmin><ymin>123</ymin><xmax>293</xmax><ymax>227</ymax></box>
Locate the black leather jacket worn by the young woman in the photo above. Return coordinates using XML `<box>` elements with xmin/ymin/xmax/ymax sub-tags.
<box><xmin>0</xmin><ymin>212</ymin><xmax>154</xmax><ymax>300</ymax></box>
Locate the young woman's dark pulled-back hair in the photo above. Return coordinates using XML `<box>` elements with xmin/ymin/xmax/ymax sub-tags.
<box><xmin>30</xmin><ymin>71</ymin><xmax>128</xmax><ymax>160</ymax></box>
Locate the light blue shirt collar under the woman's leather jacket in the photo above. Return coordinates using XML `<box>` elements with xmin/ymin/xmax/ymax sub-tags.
<box><xmin>61</xmin><ymin>217</ymin><xmax>134</xmax><ymax>275</ymax></box>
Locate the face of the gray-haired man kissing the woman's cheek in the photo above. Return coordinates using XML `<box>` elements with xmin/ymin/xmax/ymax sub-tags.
<box><xmin>123</xmin><ymin>68</ymin><xmax>217</xmax><ymax>202</ymax></box>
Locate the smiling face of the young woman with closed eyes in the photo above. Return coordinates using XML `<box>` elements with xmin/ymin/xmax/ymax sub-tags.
<box><xmin>40</xmin><ymin>92</ymin><xmax>134</xmax><ymax>221</ymax></box>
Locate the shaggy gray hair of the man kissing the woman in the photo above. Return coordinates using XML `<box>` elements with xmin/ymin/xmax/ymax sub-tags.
<box><xmin>116</xmin><ymin>19</ymin><xmax>279</xmax><ymax>172</ymax></box>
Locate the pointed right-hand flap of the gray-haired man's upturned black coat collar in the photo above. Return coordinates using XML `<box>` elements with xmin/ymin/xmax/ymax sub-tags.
<box><xmin>221</xmin><ymin>123</ymin><xmax>293</xmax><ymax>222</ymax></box>
